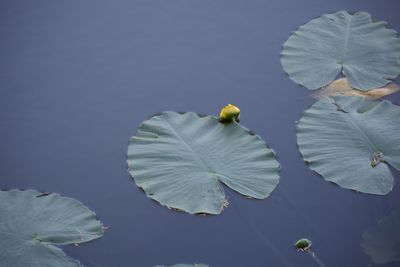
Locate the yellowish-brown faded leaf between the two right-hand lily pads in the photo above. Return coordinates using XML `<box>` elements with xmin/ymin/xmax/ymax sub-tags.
<box><xmin>311</xmin><ymin>78</ymin><xmax>400</xmax><ymax>100</ymax></box>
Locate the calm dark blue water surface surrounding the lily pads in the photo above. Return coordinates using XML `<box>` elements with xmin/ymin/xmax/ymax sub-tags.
<box><xmin>0</xmin><ymin>0</ymin><xmax>400</xmax><ymax>267</ymax></box>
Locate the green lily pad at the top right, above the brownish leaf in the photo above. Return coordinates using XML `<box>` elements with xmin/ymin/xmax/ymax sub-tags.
<box><xmin>281</xmin><ymin>11</ymin><xmax>400</xmax><ymax>91</ymax></box>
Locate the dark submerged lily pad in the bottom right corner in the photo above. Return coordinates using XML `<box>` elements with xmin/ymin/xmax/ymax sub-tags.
<box><xmin>361</xmin><ymin>209</ymin><xmax>400</xmax><ymax>264</ymax></box>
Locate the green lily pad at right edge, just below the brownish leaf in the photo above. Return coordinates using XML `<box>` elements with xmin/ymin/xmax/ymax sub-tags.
<box><xmin>297</xmin><ymin>96</ymin><xmax>400</xmax><ymax>195</ymax></box>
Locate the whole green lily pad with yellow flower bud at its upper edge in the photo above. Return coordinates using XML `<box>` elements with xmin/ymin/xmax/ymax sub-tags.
<box><xmin>128</xmin><ymin>111</ymin><xmax>279</xmax><ymax>214</ymax></box>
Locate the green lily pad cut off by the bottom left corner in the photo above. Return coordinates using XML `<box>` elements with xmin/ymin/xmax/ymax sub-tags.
<box><xmin>0</xmin><ymin>190</ymin><xmax>103</xmax><ymax>267</ymax></box>
